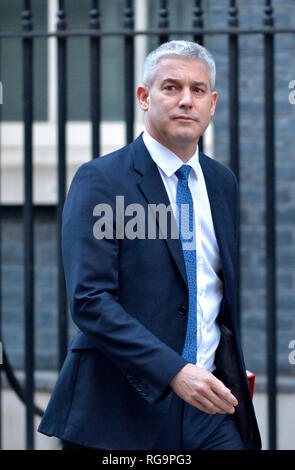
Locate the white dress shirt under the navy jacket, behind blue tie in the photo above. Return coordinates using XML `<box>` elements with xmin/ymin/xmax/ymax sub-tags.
<box><xmin>143</xmin><ymin>131</ymin><xmax>223</xmax><ymax>372</ymax></box>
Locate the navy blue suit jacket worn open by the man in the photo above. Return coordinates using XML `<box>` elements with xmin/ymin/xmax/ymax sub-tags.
<box><xmin>39</xmin><ymin>136</ymin><xmax>260</xmax><ymax>449</ymax></box>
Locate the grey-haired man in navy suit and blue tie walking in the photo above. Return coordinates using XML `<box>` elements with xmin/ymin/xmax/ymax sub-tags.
<box><xmin>39</xmin><ymin>41</ymin><xmax>261</xmax><ymax>449</ymax></box>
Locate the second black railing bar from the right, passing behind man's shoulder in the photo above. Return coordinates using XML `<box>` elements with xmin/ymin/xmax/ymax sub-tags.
<box><xmin>228</xmin><ymin>0</ymin><xmax>241</xmax><ymax>334</ymax></box>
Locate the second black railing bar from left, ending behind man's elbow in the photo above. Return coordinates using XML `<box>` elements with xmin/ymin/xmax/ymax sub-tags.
<box><xmin>57</xmin><ymin>0</ymin><xmax>68</xmax><ymax>369</ymax></box>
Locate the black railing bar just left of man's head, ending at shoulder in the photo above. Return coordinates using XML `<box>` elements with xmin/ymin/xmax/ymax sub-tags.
<box><xmin>124</xmin><ymin>0</ymin><xmax>134</xmax><ymax>144</ymax></box>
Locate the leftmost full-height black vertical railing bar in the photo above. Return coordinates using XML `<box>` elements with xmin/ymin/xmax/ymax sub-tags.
<box><xmin>21</xmin><ymin>0</ymin><xmax>35</xmax><ymax>449</ymax></box>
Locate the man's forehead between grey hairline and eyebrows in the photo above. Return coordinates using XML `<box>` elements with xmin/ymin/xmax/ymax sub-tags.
<box><xmin>154</xmin><ymin>56</ymin><xmax>210</xmax><ymax>84</ymax></box>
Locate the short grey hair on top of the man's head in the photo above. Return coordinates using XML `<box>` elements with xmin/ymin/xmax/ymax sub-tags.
<box><xmin>143</xmin><ymin>41</ymin><xmax>216</xmax><ymax>89</ymax></box>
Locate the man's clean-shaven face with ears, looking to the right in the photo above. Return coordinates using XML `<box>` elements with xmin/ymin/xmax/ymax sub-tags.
<box><xmin>137</xmin><ymin>57</ymin><xmax>217</xmax><ymax>158</ymax></box>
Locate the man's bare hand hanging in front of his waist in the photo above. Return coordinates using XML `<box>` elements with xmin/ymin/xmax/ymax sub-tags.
<box><xmin>170</xmin><ymin>364</ymin><xmax>238</xmax><ymax>414</ymax></box>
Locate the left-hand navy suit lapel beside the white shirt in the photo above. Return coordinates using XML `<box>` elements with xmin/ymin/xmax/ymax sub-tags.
<box><xmin>132</xmin><ymin>136</ymin><xmax>187</xmax><ymax>285</ymax></box>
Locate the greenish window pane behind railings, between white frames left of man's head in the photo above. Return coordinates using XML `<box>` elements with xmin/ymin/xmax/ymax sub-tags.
<box><xmin>65</xmin><ymin>0</ymin><xmax>124</xmax><ymax>121</ymax></box>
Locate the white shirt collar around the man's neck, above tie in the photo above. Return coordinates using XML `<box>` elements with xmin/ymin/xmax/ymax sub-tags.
<box><xmin>142</xmin><ymin>130</ymin><xmax>200</xmax><ymax>177</ymax></box>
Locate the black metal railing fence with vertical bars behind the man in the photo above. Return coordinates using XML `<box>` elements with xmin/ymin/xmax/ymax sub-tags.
<box><xmin>0</xmin><ymin>0</ymin><xmax>295</xmax><ymax>449</ymax></box>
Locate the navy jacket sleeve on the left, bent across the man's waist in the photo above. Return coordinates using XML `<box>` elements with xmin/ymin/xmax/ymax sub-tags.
<box><xmin>62</xmin><ymin>162</ymin><xmax>187</xmax><ymax>403</ymax></box>
